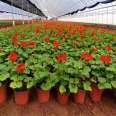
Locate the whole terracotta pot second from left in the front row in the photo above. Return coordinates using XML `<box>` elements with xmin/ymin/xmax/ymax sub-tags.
<box><xmin>15</xmin><ymin>91</ymin><xmax>29</xmax><ymax>105</ymax></box>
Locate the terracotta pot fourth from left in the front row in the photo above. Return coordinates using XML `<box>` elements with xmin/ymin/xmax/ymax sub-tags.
<box><xmin>57</xmin><ymin>92</ymin><xmax>69</xmax><ymax>105</ymax></box>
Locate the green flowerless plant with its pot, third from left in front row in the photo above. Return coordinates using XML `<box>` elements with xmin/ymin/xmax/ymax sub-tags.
<box><xmin>33</xmin><ymin>55</ymin><xmax>58</xmax><ymax>103</ymax></box>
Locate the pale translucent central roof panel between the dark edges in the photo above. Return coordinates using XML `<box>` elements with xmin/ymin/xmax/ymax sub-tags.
<box><xmin>30</xmin><ymin>0</ymin><xmax>115</xmax><ymax>18</ymax></box>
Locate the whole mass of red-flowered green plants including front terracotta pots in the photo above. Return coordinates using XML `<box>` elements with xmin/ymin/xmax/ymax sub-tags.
<box><xmin>0</xmin><ymin>24</ymin><xmax>116</xmax><ymax>105</ymax></box>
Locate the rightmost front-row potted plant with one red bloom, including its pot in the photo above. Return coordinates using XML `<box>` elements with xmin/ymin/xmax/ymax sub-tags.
<box><xmin>90</xmin><ymin>42</ymin><xmax>116</xmax><ymax>102</ymax></box>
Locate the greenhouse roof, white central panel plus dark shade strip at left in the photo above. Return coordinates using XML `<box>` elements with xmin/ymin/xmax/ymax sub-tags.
<box><xmin>0</xmin><ymin>0</ymin><xmax>115</xmax><ymax>18</ymax></box>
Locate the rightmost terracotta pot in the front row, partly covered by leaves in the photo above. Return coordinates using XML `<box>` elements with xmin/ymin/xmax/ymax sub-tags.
<box><xmin>90</xmin><ymin>84</ymin><xmax>103</xmax><ymax>102</ymax></box>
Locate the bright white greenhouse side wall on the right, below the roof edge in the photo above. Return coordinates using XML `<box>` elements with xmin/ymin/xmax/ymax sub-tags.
<box><xmin>58</xmin><ymin>2</ymin><xmax>116</xmax><ymax>25</ymax></box>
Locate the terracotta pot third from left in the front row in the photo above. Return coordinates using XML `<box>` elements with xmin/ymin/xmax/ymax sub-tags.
<box><xmin>37</xmin><ymin>89</ymin><xmax>50</xmax><ymax>103</ymax></box>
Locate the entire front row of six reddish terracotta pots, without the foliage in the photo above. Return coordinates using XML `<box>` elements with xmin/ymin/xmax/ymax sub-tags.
<box><xmin>0</xmin><ymin>84</ymin><xmax>103</xmax><ymax>106</ymax></box>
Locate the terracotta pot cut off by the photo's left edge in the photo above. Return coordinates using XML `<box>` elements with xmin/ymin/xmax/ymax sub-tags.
<box><xmin>0</xmin><ymin>85</ymin><xmax>7</xmax><ymax>104</ymax></box>
